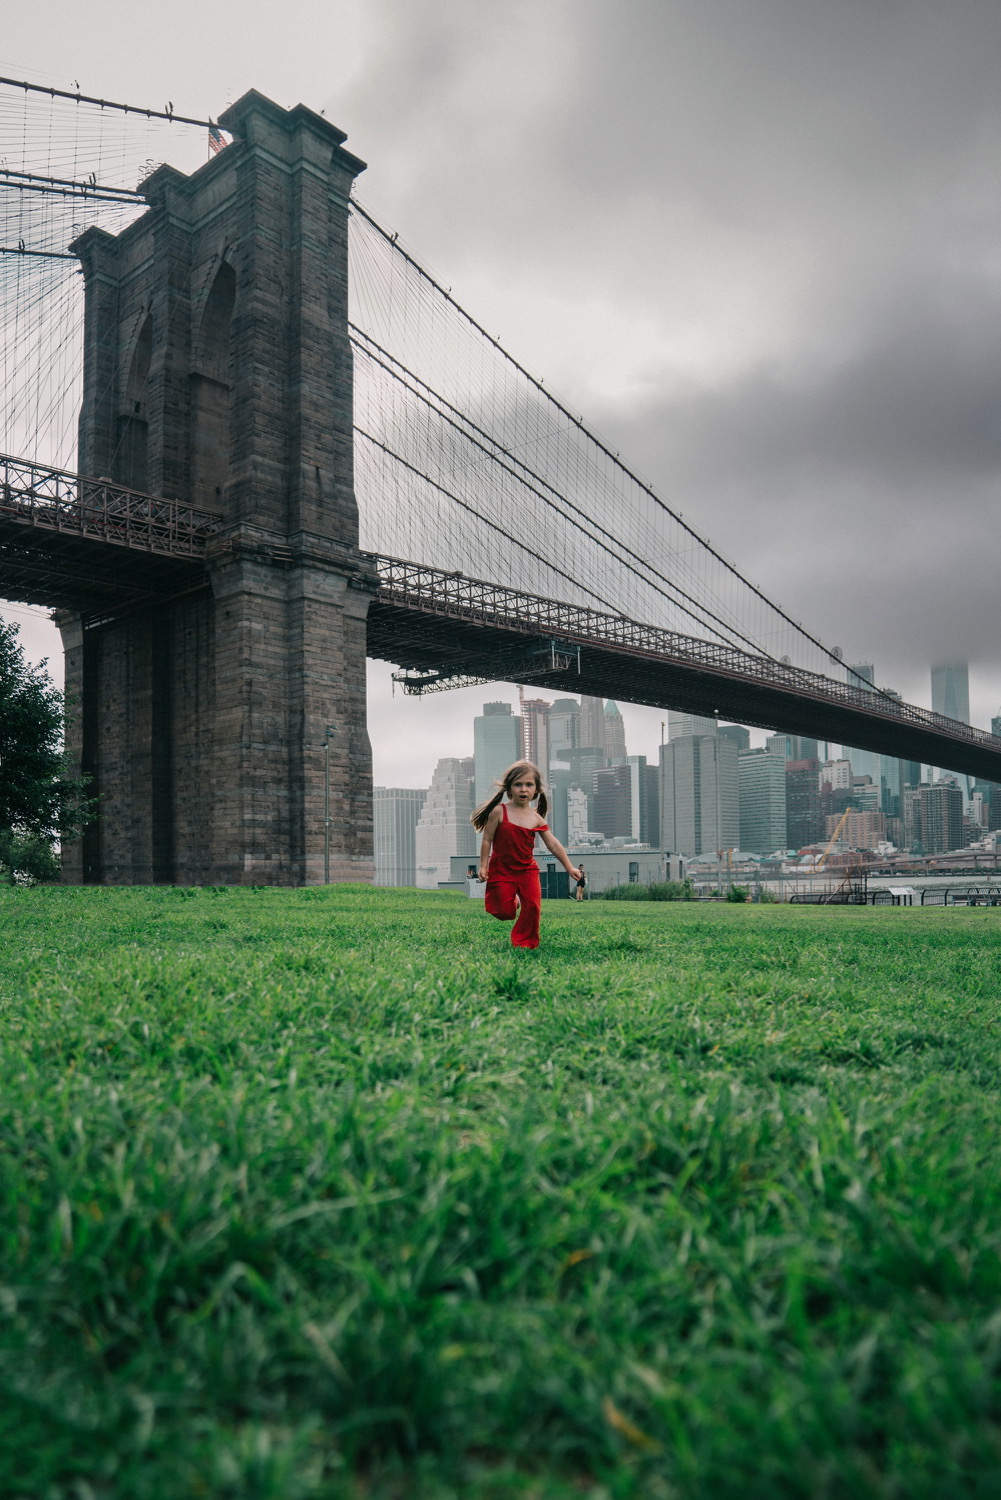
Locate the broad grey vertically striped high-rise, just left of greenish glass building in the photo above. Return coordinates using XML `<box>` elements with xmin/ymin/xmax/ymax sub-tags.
<box><xmin>660</xmin><ymin>734</ymin><xmax>740</xmax><ymax>855</ymax></box>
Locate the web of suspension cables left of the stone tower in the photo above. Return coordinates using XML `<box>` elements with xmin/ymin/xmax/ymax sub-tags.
<box><xmin>0</xmin><ymin>80</ymin><xmax>206</xmax><ymax>470</ymax></box>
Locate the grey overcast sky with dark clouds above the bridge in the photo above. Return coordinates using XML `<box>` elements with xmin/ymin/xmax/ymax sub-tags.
<box><xmin>0</xmin><ymin>0</ymin><xmax>1001</xmax><ymax>786</ymax></box>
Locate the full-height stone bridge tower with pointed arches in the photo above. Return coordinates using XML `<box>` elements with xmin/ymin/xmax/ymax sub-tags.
<box><xmin>60</xmin><ymin>93</ymin><xmax>375</xmax><ymax>885</ymax></box>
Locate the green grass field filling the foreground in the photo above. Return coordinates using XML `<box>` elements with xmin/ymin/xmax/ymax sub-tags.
<box><xmin>0</xmin><ymin>887</ymin><xmax>1001</xmax><ymax>1500</ymax></box>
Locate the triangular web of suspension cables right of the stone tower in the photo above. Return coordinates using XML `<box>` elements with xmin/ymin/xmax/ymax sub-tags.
<box><xmin>350</xmin><ymin>203</ymin><xmax>843</xmax><ymax>677</ymax></box>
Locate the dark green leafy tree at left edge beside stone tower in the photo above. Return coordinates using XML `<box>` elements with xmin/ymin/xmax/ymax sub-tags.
<box><xmin>0</xmin><ymin>621</ymin><xmax>95</xmax><ymax>881</ymax></box>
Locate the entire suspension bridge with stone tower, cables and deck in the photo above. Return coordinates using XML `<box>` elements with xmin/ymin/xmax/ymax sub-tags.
<box><xmin>0</xmin><ymin>80</ymin><xmax>1001</xmax><ymax>885</ymax></box>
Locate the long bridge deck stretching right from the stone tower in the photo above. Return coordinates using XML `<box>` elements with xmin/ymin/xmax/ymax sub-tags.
<box><xmin>369</xmin><ymin>558</ymin><xmax>1001</xmax><ymax>782</ymax></box>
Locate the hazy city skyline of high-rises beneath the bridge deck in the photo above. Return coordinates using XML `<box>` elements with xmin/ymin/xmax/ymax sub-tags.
<box><xmin>375</xmin><ymin>663</ymin><xmax>1001</xmax><ymax>888</ymax></box>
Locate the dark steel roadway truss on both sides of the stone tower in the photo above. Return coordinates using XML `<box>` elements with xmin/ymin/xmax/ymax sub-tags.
<box><xmin>7</xmin><ymin>458</ymin><xmax>1001</xmax><ymax>782</ymax></box>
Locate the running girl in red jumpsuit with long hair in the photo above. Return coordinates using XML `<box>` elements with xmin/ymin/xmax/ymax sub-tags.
<box><xmin>471</xmin><ymin>761</ymin><xmax>579</xmax><ymax>948</ymax></box>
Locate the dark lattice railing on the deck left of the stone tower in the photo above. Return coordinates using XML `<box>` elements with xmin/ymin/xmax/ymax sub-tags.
<box><xmin>0</xmin><ymin>455</ymin><xmax>222</xmax><ymax>558</ymax></box>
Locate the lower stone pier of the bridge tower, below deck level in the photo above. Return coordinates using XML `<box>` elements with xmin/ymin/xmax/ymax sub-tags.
<box><xmin>59</xmin><ymin>542</ymin><xmax>379</xmax><ymax>885</ymax></box>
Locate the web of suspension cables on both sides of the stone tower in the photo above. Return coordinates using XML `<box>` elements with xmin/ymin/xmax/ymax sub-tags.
<box><xmin>0</xmin><ymin>78</ymin><xmax>924</xmax><ymax>723</ymax></box>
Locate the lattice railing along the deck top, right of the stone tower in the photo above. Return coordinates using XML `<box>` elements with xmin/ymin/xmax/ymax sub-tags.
<box><xmin>374</xmin><ymin>558</ymin><xmax>1001</xmax><ymax>752</ymax></box>
